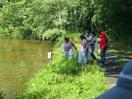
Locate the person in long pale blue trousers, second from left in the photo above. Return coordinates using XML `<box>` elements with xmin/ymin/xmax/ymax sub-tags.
<box><xmin>79</xmin><ymin>35</ymin><xmax>88</xmax><ymax>64</ymax></box>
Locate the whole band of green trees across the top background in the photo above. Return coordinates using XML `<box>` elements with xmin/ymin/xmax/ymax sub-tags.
<box><xmin>0</xmin><ymin>0</ymin><xmax>132</xmax><ymax>40</ymax></box>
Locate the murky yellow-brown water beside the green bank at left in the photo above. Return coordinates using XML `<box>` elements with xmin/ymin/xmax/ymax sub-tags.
<box><xmin>0</xmin><ymin>39</ymin><xmax>52</xmax><ymax>98</ymax></box>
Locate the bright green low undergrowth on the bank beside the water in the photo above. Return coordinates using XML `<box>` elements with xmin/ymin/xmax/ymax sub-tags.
<box><xmin>17</xmin><ymin>47</ymin><xmax>106</xmax><ymax>99</ymax></box>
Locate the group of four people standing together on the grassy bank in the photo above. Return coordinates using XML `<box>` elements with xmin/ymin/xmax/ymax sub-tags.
<box><xmin>63</xmin><ymin>32</ymin><xmax>107</xmax><ymax>65</ymax></box>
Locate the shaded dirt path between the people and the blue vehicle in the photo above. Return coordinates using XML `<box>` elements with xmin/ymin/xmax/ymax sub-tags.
<box><xmin>104</xmin><ymin>48</ymin><xmax>132</xmax><ymax>88</ymax></box>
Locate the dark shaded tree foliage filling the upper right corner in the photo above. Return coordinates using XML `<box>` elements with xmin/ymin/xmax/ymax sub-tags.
<box><xmin>93</xmin><ymin>0</ymin><xmax>132</xmax><ymax>39</ymax></box>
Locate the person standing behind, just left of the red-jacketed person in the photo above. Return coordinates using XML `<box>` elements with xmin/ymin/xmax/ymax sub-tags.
<box><xmin>85</xmin><ymin>32</ymin><xmax>97</xmax><ymax>60</ymax></box>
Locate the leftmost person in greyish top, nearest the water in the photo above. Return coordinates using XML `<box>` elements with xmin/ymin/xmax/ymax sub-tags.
<box><xmin>63</xmin><ymin>37</ymin><xmax>77</xmax><ymax>57</ymax></box>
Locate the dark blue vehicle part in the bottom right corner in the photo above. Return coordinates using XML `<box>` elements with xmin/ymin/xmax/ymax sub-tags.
<box><xmin>96</xmin><ymin>61</ymin><xmax>132</xmax><ymax>99</ymax></box>
